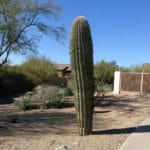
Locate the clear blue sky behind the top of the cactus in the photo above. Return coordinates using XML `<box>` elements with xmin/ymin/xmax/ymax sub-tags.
<box><xmin>10</xmin><ymin>0</ymin><xmax>150</xmax><ymax>67</ymax></box>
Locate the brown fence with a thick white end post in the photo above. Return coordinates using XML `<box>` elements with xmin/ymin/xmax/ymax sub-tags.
<box><xmin>114</xmin><ymin>71</ymin><xmax>150</xmax><ymax>94</ymax></box>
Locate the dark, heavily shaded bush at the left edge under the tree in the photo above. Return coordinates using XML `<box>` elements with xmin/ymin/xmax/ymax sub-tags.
<box><xmin>0</xmin><ymin>66</ymin><xmax>34</xmax><ymax>97</ymax></box>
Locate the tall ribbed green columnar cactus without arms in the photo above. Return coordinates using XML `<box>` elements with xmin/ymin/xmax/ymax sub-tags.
<box><xmin>70</xmin><ymin>16</ymin><xmax>94</xmax><ymax>136</ymax></box>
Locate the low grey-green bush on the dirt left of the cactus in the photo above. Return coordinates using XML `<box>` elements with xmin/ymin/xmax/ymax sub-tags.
<box><xmin>15</xmin><ymin>84</ymin><xmax>69</xmax><ymax>110</ymax></box>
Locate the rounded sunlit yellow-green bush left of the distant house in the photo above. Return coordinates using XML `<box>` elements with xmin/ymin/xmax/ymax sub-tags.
<box><xmin>20</xmin><ymin>57</ymin><xmax>56</xmax><ymax>86</ymax></box>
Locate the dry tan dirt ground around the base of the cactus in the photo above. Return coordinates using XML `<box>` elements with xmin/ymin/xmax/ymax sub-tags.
<box><xmin>0</xmin><ymin>93</ymin><xmax>150</xmax><ymax>150</ymax></box>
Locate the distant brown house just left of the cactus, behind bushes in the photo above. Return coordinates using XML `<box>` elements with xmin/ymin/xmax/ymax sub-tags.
<box><xmin>56</xmin><ymin>64</ymin><xmax>71</xmax><ymax>77</ymax></box>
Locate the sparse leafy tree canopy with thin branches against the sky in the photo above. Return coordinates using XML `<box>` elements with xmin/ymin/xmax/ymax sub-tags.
<box><xmin>0</xmin><ymin>0</ymin><xmax>64</xmax><ymax>66</ymax></box>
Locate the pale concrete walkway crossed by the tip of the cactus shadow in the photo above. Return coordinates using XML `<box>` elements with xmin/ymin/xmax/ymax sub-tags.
<box><xmin>119</xmin><ymin>117</ymin><xmax>150</xmax><ymax>150</ymax></box>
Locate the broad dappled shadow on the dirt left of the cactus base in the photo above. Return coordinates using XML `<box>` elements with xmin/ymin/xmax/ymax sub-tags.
<box><xmin>0</xmin><ymin>110</ymin><xmax>77</xmax><ymax>136</ymax></box>
